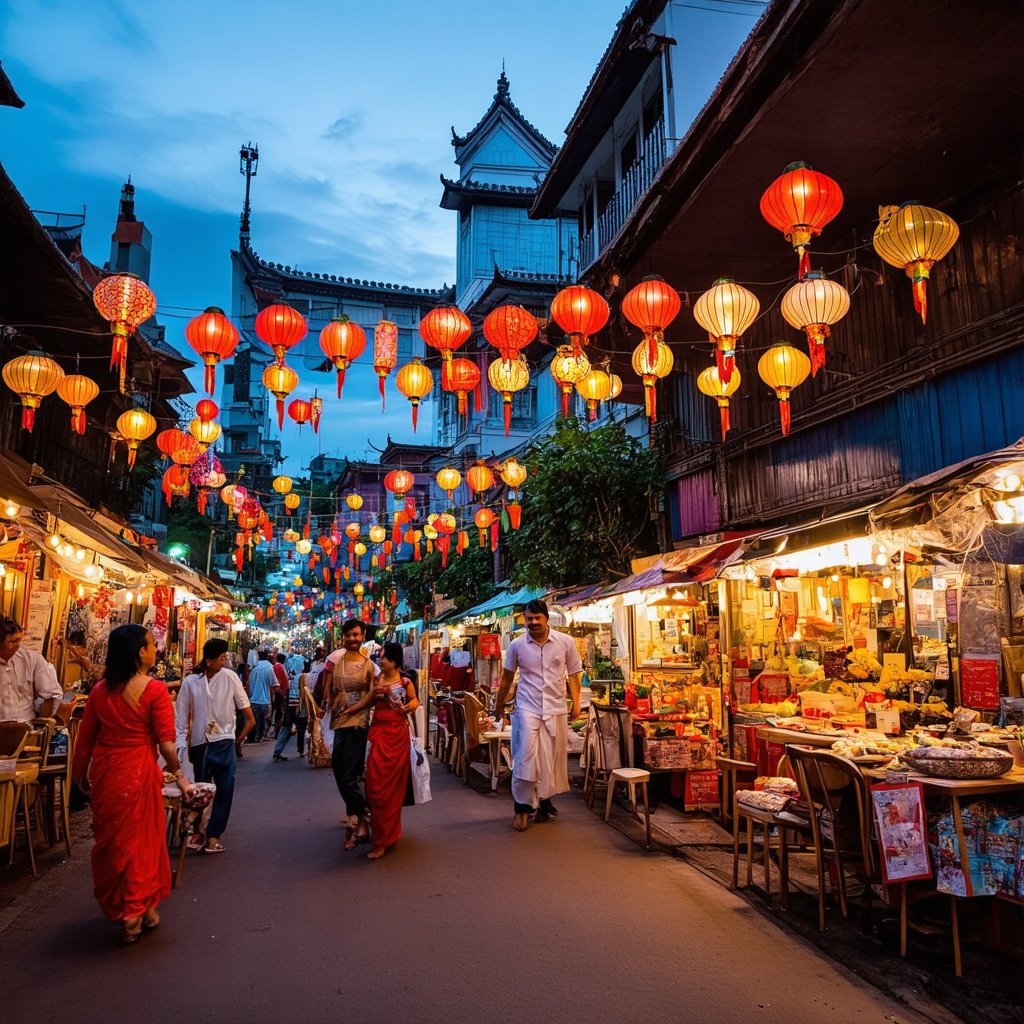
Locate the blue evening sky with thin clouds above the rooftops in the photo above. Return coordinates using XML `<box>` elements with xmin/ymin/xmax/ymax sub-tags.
<box><xmin>0</xmin><ymin>0</ymin><xmax>760</xmax><ymax>474</ymax></box>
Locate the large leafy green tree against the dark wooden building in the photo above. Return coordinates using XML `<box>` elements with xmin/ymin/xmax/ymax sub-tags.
<box><xmin>503</xmin><ymin>419</ymin><xmax>663</xmax><ymax>587</ymax></box>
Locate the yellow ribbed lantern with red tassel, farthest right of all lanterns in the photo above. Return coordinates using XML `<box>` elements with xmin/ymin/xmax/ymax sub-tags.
<box><xmin>871</xmin><ymin>202</ymin><xmax>959</xmax><ymax>324</ymax></box>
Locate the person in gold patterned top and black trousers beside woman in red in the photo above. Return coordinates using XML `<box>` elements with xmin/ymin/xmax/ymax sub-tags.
<box><xmin>321</xmin><ymin>618</ymin><xmax>380</xmax><ymax>850</ymax></box>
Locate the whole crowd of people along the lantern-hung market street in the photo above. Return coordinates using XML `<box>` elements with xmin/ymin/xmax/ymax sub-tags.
<box><xmin>0</xmin><ymin>601</ymin><xmax>582</xmax><ymax>942</ymax></box>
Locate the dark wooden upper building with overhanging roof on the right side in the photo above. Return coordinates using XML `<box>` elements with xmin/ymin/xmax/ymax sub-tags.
<box><xmin>532</xmin><ymin>0</ymin><xmax>1024</xmax><ymax>544</ymax></box>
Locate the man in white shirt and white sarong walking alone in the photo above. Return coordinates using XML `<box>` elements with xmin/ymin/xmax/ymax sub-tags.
<box><xmin>495</xmin><ymin>601</ymin><xmax>583</xmax><ymax>831</ymax></box>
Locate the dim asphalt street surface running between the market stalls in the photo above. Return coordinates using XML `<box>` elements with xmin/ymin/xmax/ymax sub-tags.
<box><xmin>0</xmin><ymin>743</ymin><xmax>946</xmax><ymax>1024</ymax></box>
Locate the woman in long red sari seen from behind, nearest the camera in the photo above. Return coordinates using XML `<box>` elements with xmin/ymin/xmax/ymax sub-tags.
<box><xmin>72</xmin><ymin>625</ymin><xmax>191</xmax><ymax>942</ymax></box>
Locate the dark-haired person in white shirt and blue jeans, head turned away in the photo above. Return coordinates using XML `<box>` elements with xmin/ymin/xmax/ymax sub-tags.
<box><xmin>175</xmin><ymin>639</ymin><xmax>256</xmax><ymax>853</ymax></box>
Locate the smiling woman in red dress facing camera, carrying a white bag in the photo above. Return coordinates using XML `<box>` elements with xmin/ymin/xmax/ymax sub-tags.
<box><xmin>342</xmin><ymin>643</ymin><xmax>420</xmax><ymax>860</ymax></box>
